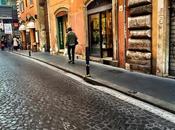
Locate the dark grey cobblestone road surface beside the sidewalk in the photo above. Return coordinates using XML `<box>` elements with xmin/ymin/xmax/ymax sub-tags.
<box><xmin>0</xmin><ymin>52</ymin><xmax>175</xmax><ymax>130</ymax></box>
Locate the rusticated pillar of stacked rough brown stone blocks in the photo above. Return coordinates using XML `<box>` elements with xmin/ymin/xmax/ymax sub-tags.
<box><xmin>126</xmin><ymin>0</ymin><xmax>152</xmax><ymax>73</ymax></box>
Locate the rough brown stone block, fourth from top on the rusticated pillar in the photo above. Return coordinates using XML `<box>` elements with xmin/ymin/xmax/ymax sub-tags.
<box><xmin>128</xmin><ymin>39</ymin><xmax>151</xmax><ymax>52</ymax></box>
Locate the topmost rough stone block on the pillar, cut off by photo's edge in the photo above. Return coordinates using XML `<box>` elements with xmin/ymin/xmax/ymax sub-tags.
<box><xmin>128</xmin><ymin>0</ymin><xmax>152</xmax><ymax>7</ymax></box>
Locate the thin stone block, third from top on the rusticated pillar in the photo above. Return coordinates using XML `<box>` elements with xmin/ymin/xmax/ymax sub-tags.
<box><xmin>129</xmin><ymin>29</ymin><xmax>151</xmax><ymax>38</ymax></box>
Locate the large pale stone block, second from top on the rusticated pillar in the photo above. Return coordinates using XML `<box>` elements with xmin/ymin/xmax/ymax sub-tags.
<box><xmin>128</xmin><ymin>15</ymin><xmax>151</xmax><ymax>29</ymax></box>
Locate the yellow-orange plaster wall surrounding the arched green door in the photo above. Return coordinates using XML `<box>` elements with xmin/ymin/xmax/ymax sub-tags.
<box><xmin>48</xmin><ymin>0</ymin><xmax>85</xmax><ymax>54</ymax></box>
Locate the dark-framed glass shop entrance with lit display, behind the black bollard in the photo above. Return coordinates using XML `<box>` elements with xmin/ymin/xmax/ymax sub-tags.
<box><xmin>88</xmin><ymin>9</ymin><xmax>113</xmax><ymax>58</ymax></box>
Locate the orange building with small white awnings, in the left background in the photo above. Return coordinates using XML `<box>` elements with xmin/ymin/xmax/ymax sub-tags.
<box><xmin>17</xmin><ymin>0</ymin><xmax>50</xmax><ymax>51</ymax></box>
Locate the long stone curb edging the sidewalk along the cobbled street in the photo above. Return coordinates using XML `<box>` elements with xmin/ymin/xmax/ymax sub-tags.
<box><xmin>13</xmin><ymin>52</ymin><xmax>175</xmax><ymax>114</ymax></box>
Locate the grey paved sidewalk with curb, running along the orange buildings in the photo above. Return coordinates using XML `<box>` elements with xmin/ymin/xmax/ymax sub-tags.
<box><xmin>13</xmin><ymin>51</ymin><xmax>175</xmax><ymax>114</ymax></box>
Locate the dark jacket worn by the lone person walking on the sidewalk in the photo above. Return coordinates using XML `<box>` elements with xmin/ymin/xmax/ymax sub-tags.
<box><xmin>66</xmin><ymin>31</ymin><xmax>77</xmax><ymax>46</ymax></box>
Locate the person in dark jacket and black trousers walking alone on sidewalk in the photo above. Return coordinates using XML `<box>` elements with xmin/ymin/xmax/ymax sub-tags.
<box><xmin>66</xmin><ymin>27</ymin><xmax>78</xmax><ymax>64</ymax></box>
